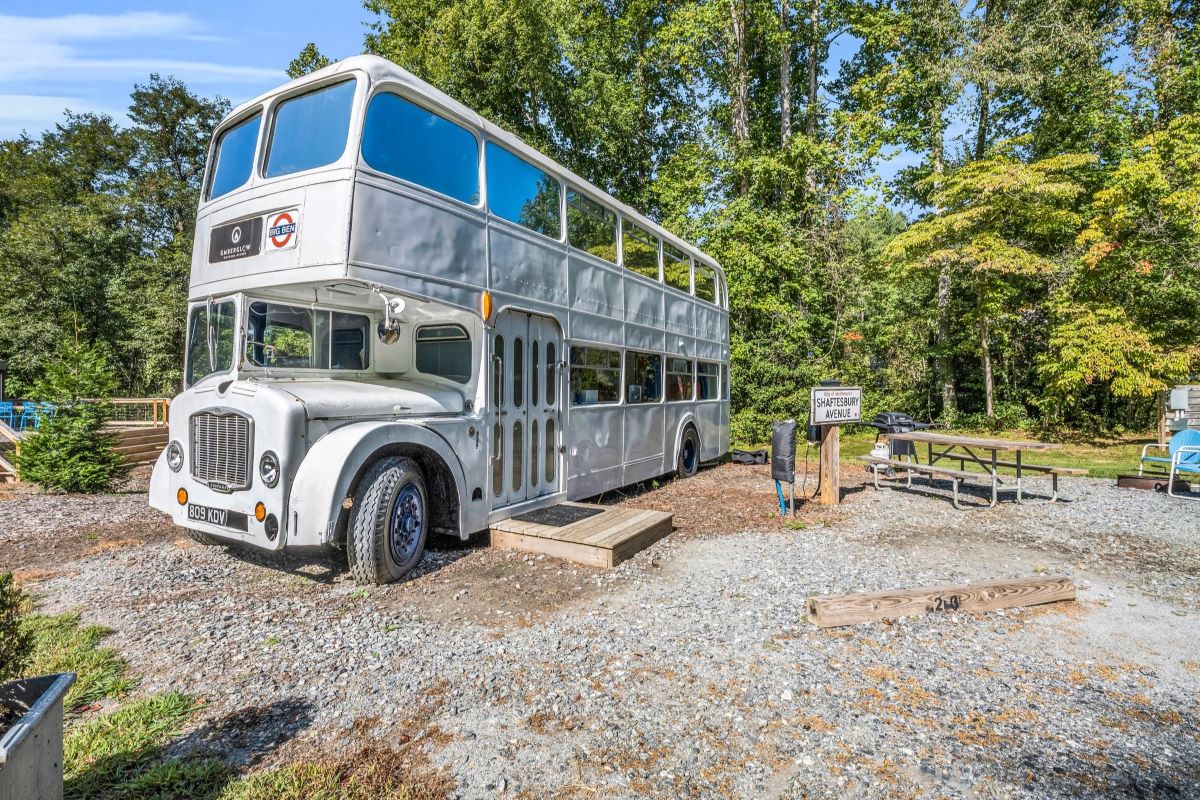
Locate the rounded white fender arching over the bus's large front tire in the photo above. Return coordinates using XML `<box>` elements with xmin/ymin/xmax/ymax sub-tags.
<box><xmin>288</xmin><ymin>421</ymin><xmax>467</xmax><ymax>547</ymax></box>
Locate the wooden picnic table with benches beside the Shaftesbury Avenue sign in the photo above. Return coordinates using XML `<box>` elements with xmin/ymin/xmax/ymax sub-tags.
<box><xmin>860</xmin><ymin>431</ymin><xmax>1087</xmax><ymax>509</ymax></box>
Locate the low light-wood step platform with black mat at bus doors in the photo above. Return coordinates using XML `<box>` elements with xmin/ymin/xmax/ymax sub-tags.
<box><xmin>491</xmin><ymin>503</ymin><xmax>674</xmax><ymax>567</ymax></box>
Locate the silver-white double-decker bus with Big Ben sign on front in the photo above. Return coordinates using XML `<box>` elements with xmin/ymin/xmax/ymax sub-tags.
<box><xmin>150</xmin><ymin>55</ymin><xmax>730</xmax><ymax>583</ymax></box>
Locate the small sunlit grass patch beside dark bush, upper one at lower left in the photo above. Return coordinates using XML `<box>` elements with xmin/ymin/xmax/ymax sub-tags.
<box><xmin>22</xmin><ymin>613</ymin><xmax>138</xmax><ymax>711</ymax></box>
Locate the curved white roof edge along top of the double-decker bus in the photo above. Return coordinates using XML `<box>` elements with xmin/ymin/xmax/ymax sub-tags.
<box><xmin>218</xmin><ymin>55</ymin><xmax>725</xmax><ymax>276</ymax></box>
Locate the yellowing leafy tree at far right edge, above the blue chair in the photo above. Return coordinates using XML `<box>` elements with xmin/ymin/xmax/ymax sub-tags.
<box><xmin>1039</xmin><ymin>114</ymin><xmax>1200</xmax><ymax>420</ymax></box>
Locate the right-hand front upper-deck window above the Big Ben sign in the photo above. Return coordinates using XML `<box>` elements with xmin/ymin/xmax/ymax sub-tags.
<box><xmin>264</xmin><ymin>79</ymin><xmax>354</xmax><ymax>178</ymax></box>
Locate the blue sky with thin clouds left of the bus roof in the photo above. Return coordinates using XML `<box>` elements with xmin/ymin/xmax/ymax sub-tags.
<box><xmin>0</xmin><ymin>0</ymin><xmax>371</xmax><ymax>138</ymax></box>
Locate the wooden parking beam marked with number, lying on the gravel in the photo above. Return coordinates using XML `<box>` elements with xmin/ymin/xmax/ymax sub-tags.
<box><xmin>806</xmin><ymin>575</ymin><xmax>1075</xmax><ymax>627</ymax></box>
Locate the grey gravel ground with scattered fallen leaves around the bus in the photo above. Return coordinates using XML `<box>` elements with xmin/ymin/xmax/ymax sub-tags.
<box><xmin>0</xmin><ymin>465</ymin><xmax>1200</xmax><ymax>799</ymax></box>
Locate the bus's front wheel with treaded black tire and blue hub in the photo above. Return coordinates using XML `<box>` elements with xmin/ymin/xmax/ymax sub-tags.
<box><xmin>346</xmin><ymin>457</ymin><xmax>430</xmax><ymax>585</ymax></box>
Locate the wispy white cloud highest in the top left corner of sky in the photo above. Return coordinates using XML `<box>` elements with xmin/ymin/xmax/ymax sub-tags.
<box><xmin>0</xmin><ymin>12</ymin><xmax>283</xmax><ymax>83</ymax></box>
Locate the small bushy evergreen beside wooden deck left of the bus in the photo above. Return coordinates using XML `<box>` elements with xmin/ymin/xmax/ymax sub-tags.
<box><xmin>17</xmin><ymin>342</ymin><xmax>124</xmax><ymax>492</ymax></box>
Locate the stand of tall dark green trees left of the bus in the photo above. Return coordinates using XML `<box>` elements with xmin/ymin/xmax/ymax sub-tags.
<box><xmin>0</xmin><ymin>76</ymin><xmax>229</xmax><ymax>395</ymax></box>
